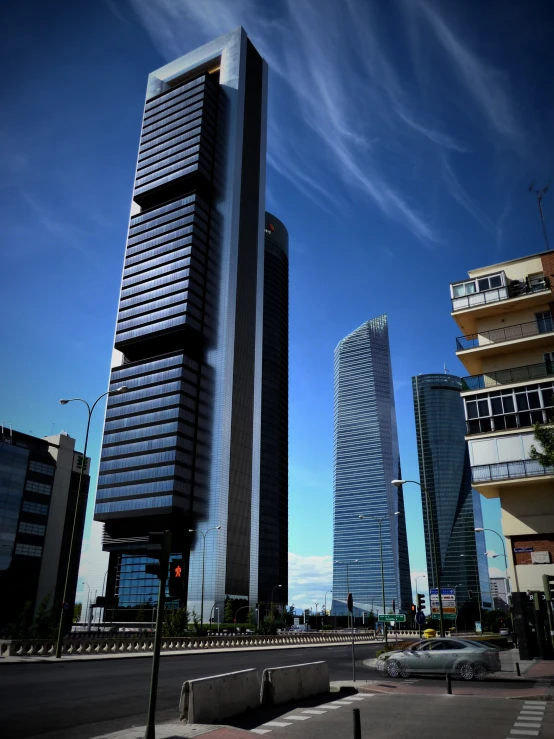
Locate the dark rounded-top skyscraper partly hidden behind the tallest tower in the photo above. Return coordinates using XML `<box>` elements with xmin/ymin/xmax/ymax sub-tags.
<box><xmin>258</xmin><ymin>213</ymin><xmax>289</xmax><ymax>603</ymax></box>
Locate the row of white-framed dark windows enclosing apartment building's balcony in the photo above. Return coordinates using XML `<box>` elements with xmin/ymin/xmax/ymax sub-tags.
<box><xmin>464</xmin><ymin>382</ymin><xmax>554</xmax><ymax>420</ymax></box>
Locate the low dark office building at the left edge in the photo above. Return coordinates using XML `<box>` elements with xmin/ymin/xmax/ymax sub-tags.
<box><xmin>0</xmin><ymin>427</ymin><xmax>90</xmax><ymax>626</ymax></box>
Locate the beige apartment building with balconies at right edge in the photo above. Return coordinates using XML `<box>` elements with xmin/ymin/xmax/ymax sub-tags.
<box><xmin>450</xmin><ymin>251</ymin><xmax>554</xmax><ymax>656</ymax></box>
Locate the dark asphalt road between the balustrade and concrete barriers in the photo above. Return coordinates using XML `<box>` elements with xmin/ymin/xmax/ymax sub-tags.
<box><xmin>0</xmin><ymin>643</ymin><xmax>382</xmax><ymax>739</ymax></box>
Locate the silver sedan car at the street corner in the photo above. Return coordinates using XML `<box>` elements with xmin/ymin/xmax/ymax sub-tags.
<box><xmin>376</xmin><ymin>638</ymin><xmax>500</xmax><ymax>680</ymax></box>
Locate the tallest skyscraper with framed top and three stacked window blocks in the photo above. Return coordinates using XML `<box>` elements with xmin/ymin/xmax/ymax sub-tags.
<box><xmin>95</xmin><ymin>28</ymin><xmax>267</xmax><ymax>620</ymax></box>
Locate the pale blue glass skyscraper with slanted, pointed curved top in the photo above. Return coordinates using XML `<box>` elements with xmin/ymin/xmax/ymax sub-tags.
<box><xmin>332</xmin><ymin>315</ymin><xmax>412</xmax><ymax>615</ymax></box>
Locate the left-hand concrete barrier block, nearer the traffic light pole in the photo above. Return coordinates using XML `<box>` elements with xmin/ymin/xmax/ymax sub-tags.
<box><xmin>179</xmin><ymin>669</ymin><xmax>260</xmax><ymax>724</ymax></box>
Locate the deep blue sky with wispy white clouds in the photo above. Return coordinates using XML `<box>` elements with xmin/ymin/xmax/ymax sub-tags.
<box><xmin>0</xmin><ymin>0</ymin><xmax>554</xmax><ymax>606</ymax></box>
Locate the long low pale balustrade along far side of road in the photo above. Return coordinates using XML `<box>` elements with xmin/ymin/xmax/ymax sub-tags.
<box><xmin>0</xmin><ymin>630</ymin><xmax>418</xmax><ymax>658</ymax></box>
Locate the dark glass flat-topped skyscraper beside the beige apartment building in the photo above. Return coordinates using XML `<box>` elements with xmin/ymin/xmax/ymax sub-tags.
<box><xmin>412</xmin><ymin>374</ymin><xmax>491</xmax><ymax>605</ymax></box>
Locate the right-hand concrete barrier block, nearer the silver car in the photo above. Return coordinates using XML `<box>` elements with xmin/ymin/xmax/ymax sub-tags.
<box><xmin>260</xmin><ymin>662</ymin><xmax>330</xmax><ymax>706</ymax></box>
